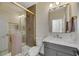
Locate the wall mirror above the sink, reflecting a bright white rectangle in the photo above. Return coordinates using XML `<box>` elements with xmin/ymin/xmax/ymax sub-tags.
<box><xmin>49</xmin><ymin>7</ymin><xmax>66</xmax><ymax>32</ymax></box>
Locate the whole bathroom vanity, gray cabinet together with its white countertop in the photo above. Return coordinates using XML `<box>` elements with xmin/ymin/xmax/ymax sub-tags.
<box><xmin>43</xmin><ymin>33</ymin><xmax>78</xmax><ymax>56</ymax></box>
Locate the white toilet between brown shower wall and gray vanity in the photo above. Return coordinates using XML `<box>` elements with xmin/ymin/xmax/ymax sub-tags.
<box><xmin>28</xmin><ymin>38</ymin><xmax>43</xmax><ymax>56</ymax></box>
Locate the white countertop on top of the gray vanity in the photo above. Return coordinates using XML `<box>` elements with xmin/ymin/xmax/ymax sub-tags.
<box><xmin>43</xmin><ymin>36</ymin><xmax>79</xmax><ymax>49</ymax></box>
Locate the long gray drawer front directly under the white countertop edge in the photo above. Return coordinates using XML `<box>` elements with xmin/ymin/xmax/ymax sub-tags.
<box><xmin>44</xmin><ymin>42</ymin><xmax>76</xmax><ymax>55</ymax></box>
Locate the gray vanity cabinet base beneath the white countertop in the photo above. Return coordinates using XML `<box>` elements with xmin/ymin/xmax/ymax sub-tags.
<box><xmin>44</xmin><ymin>42</ymin><xmax>77</xmax><ymax>56</ymax></box>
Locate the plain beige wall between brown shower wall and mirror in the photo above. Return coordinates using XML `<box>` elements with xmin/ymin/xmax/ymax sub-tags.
<box><xmin>36</xmin><ymin>2</ymin><xmax>49</xmax><ymax>38</ymax></box>
